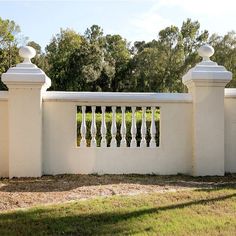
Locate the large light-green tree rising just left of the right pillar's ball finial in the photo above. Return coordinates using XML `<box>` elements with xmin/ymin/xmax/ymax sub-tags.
<box><xmin>130</xmin><ymin>19</ymin><xmax>208</xmax><ymax>92</ymax></box>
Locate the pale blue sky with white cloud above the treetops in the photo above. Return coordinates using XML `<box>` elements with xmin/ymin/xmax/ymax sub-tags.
<box><xmin>0</xmin><ymin>0</ymin><xmax>236</xmax><ymax>48</ymax></box>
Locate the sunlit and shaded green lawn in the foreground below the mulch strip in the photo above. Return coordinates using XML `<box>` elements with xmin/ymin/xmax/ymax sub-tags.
<box><xmin>0</xmin><ymin>186</ymin><xmax>236</xmax><ymax>236</ymax></box>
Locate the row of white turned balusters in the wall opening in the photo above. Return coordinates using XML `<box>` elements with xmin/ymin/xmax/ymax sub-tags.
<box><xmin>79</xmin><ymin>104</ymin><xmax>157</xmax><ymax>148</ymax></box>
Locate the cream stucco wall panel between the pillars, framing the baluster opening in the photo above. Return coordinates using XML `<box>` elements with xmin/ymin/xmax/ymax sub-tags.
<box><xmin>43</xmin><ymin>93</ymin><xmax>192</xmax><ymax>174</ymax></box>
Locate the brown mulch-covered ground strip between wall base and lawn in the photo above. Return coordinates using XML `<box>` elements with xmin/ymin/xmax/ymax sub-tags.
<box><xmin>0</xmin><ymin>175</ymin><xmax>236</xmax><ymax>211</ymax></box>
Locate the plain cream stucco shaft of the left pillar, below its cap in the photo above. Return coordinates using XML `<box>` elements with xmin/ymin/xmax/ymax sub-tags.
<box><xmin>8</xmin><ymin>88</ymin><xmax>42</xmax><ymax>177</ymax></box>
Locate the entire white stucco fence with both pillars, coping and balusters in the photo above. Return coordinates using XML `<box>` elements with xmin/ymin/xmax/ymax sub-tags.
<box><xmin>0</xmin><ymin>45</ymin><xmax>236</xmax><ymax>178</ymax></box>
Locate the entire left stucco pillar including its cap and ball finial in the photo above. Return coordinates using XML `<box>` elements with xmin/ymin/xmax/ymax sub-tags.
<box><xmin>2</xmin><ymin>46</ymin><xmax>51</xmax><ymax>178</ymax></box>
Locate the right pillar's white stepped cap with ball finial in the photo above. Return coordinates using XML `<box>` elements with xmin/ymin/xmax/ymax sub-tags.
<box><xmin>182</xmin><ymin>44</ymin><xmax>232</xmax><ymax>87</ymax></box>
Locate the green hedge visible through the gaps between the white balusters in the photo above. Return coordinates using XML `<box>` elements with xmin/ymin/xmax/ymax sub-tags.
<box><xmin>77</xmin><ymin>109</ymin><xmax>160</xmax><ymax>146</ymax></box>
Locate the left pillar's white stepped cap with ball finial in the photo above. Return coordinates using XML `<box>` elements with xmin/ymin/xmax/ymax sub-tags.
<box><xmin>2</xmin><ymin>46</ymin><xmax>51</xmax><ymax>90</ymax></box>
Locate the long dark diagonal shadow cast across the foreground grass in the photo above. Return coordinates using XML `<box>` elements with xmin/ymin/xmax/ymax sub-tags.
<box><xmin>0</xmin><ymin>194</ymin><xmax>236</xmax><ymax>235</ymax></box>
